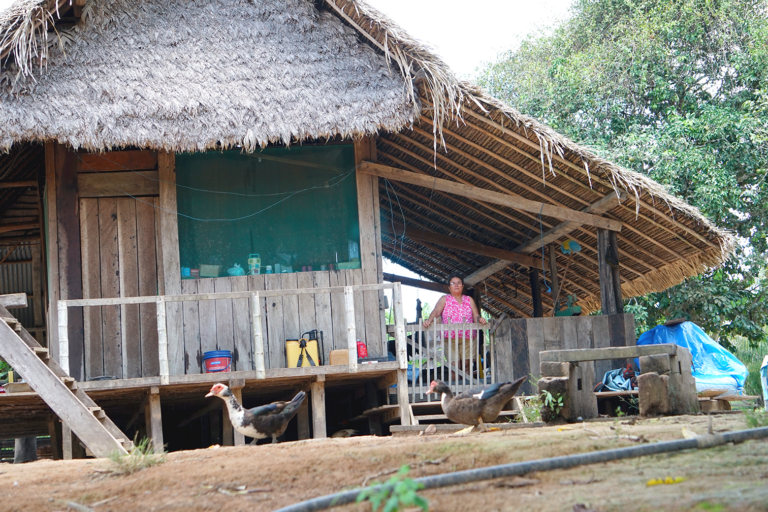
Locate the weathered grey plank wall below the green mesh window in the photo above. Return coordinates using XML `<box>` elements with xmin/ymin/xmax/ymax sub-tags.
<box><xmin>181</xmin><ymin>269</ymin><xmax>372</xmax><ymax>373</ymax></box>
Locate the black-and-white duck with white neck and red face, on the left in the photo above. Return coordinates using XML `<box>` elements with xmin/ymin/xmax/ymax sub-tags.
<box><xmin>205</xmin><ymin>382</ymin><xmax>306</xmax><ymax>444</ymax></box>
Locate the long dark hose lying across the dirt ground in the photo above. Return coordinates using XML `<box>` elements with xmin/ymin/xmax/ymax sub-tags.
<box><xmin>275</xmin><ymin>427</ymin><xmax>768</xmax><ymax>512</ymax></box>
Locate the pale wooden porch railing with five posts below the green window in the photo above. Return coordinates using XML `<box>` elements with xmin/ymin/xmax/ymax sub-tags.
<box><xmin>58</xmin><ymin>283</ymin><xmax>408</xmax><ymax>384</ymax></box>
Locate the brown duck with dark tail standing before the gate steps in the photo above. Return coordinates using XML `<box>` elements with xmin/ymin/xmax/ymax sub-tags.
<box><xmin>427</xmin><ymin>377</ymin><xmax>525</xmax><ymax>431</ymax></box>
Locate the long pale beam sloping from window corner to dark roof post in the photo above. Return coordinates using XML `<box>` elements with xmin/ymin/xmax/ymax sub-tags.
<box><xmin>358</xmin><ymin>162</ymin><xmax>622</xmax><ymax>231</ymax></box>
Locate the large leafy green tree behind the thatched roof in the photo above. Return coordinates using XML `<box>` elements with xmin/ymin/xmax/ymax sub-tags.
<box><xmin>478</xmin><ymin>0</ymin><xmax>768</xmax><ymax>346</ymax></box>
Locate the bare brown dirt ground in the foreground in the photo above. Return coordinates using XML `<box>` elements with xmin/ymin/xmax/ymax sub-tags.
<box><xmin>0</xmin><ymin>414</ymin><xmax>768</xmax><ymax>512</ymax></box>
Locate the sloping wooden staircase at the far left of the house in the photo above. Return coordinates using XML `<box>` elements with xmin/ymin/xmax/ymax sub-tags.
<box><xmin>0</xmin><ymin>297</ymin><xmax>133</xmax><ymax>457</ymax></box>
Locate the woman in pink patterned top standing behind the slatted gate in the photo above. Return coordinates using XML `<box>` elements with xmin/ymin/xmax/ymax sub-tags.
<box><xmin>424</xmin><ymin>275</ymin><xmax>487</xmax><ymax>372</ymax></box>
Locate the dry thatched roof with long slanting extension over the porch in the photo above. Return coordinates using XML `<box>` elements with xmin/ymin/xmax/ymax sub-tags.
<box><xmin>0</xmin><ymin>0</ymin><xmax>734</xmax><ymax>316</ymax></box>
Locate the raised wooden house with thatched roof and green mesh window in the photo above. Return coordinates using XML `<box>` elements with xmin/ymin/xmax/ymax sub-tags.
<box><xmin>0</xmin><ymin>0</ymin><xmax>734</xmax><ymax>456</ymax></box>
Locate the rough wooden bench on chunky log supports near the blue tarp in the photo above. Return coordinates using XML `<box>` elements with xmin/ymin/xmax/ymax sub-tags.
<box><xmin>538</xmin><ymin>344</ymin><xmax>699</xmax><ymax>421</ymax></box>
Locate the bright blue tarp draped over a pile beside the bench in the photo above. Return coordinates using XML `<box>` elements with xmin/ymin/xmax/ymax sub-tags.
<box><xmin>637</xmin><ymin>322</ymin><xmax>749</xmax><ymax>394</ymax></box>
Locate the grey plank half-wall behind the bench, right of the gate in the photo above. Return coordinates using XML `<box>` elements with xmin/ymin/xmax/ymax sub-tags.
<box><xmin>494</xmin><ymin>314</ymin><xmax>636</xmax><ymax>394</ymax></box>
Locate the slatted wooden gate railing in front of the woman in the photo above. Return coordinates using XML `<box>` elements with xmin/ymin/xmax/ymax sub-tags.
<box><xmin>387</xmin><ymin>319</ymin><xmax>496</xmax><ymax>403</ymax></box>
